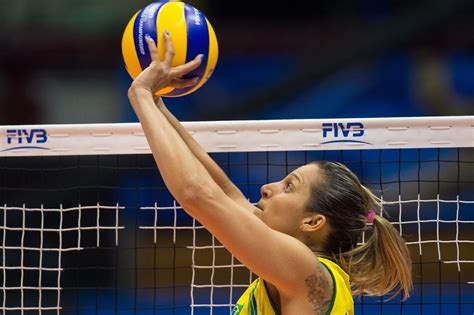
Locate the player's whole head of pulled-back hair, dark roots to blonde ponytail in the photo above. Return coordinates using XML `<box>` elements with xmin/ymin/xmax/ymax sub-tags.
<box><xmin>307</xmin><ymin>161</ymin><xmax>413</xmax><ymax>299</ymax></box>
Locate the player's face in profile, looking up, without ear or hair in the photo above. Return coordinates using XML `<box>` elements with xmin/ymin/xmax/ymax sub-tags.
<box><xmin>255</xmin><ymin>164</ymin><xmax>318</xmax><ymax>237</ymax></box>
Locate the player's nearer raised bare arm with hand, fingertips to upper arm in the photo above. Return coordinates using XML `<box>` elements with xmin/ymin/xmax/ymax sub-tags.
<box><xmin>128</xmin><ymin>33</ymin><xmax>319</xmax><ymax>295</ymax></box>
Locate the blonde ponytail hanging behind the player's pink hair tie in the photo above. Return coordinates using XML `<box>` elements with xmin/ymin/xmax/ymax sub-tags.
<box><xmin>338</xmin><ymin>215</ymin><xmax>413</xmax><ymax>300</ymax></box>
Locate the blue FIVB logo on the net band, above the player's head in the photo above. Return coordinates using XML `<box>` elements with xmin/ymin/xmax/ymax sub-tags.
<box><xmin>322</xmin><ymin>122</ymin><xmax>371</xmax><ymax>144</ymax></box>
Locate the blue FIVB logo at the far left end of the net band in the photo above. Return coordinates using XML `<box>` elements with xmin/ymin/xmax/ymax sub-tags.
<box><xmin>3</xmin><ymin>129</ymin><xmax>49</xmax><ymax>151</ymax></box>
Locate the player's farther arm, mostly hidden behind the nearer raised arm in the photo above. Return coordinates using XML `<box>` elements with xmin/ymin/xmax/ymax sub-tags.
<box><xmin>155</xmin><ymin>97</ymin><xmax>255</xmax><ymax>212</ymax></box>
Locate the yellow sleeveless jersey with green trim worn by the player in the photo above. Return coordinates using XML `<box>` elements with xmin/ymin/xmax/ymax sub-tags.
<box><xmin>232</xmin><ymin>257</ymin><xmax>354</xmax><ymax>315</ymax></box>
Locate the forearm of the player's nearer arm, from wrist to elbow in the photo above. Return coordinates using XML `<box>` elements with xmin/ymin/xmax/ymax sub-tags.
<box><xmin>129</xmin><ymin>88</ymin><xmax>217</xmax><ymax>204</ymax></box>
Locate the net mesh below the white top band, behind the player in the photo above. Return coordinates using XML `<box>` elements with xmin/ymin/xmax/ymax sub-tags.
<box><xmin>0</xmin><ymin>140</ymin><xmax>474</xmax><ymax>314</ymax></box>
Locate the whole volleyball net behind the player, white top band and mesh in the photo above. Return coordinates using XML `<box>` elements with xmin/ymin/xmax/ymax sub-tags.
<box><xmin>0</xmin><ymin>116</ymin><xmax>474</xmax><ymax>315</ymax></box>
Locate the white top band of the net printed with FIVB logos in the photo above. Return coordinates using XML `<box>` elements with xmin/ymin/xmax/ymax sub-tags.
<box><xmin>0</xmin><ymin>116</ymin><xmax>474</xmax><ymax>156</ymax></box>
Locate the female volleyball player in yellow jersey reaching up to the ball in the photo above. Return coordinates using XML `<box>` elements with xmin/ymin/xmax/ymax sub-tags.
<box><xmin>128</xmin><ymin>35</ymin><xmax>412</xmax><ymax>315</ymax></box>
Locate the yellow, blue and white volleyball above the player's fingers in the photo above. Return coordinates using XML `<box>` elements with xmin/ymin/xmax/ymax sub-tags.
<box><xmin>122</xmin><ymin>1</ymin><xmax>218</xmax><ymax>97</ymax></box>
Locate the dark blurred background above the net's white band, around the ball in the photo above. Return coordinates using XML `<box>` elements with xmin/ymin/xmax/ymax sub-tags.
<box><xmin>0</xmin><ymin>0</ymin><xmax>474</xmax><ymax>124</ymax></box>
